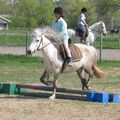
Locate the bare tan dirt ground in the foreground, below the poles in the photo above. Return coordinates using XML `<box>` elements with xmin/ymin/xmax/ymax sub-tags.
<box><xmin>0</xmin><ymin>95</ymin><xmax>120</xmax><ymax>120</ymax></box>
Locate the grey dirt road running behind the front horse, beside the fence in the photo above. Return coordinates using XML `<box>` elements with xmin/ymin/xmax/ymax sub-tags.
<box><xmin>0</xmin><ymin>46</ymin><xmax>120</xmax><ymax>60</ymax></box>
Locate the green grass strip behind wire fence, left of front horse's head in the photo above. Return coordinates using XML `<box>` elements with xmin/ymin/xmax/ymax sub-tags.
<box><xmin>0</xmin><ymin>28</ymin><xmax>32</xmax><ymax>54</ymax></box>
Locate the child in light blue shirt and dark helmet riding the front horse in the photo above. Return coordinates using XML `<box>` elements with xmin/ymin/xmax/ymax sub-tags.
<box><xmin>52</xmin><ymin>7</ymin><xmax>72</xmax><ymax>65</ymax></box>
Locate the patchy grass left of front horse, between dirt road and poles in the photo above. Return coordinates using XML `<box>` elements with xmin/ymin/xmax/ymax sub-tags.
<box><xmin>0</xmin><ymin>55</ymin><xmax>43</xmax><ymax>82</ymax></box>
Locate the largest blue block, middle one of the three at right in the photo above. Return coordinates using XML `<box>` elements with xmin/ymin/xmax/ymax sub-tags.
<box><xmin>93</xmin><ymin>92</ymin><xmax>109</xmax><ymax>103</ymax></box>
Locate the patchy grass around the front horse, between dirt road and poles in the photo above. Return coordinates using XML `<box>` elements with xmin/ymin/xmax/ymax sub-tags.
<box><xmin>0</xmin><ymin>55</ymin><xmax>120</xmax><ymax>91</ymax></box>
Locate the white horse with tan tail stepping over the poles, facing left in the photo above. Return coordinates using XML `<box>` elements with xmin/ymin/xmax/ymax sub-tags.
<box><xmin>28</xmin><ymin>27</ymin><xmax>104</xmax><ymax>99</ymax></box>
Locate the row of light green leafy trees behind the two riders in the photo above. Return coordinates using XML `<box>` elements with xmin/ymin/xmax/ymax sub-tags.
<box><xmin>0</xmin><ymin>0</ymin><xmax>96</xmax><ymax>27</ymax></box>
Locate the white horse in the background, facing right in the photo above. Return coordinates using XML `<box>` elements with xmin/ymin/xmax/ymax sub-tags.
<box><xmin>68</xmin><ymin>21</ymin><xmax>107</xmax><ymax>45</ymax></box>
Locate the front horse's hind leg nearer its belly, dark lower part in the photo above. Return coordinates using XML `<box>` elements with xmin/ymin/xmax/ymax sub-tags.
<box><xmin>76</xmin><ymin>68</ymin><xmax>89</xmax><ymax>90</ymax></box>
